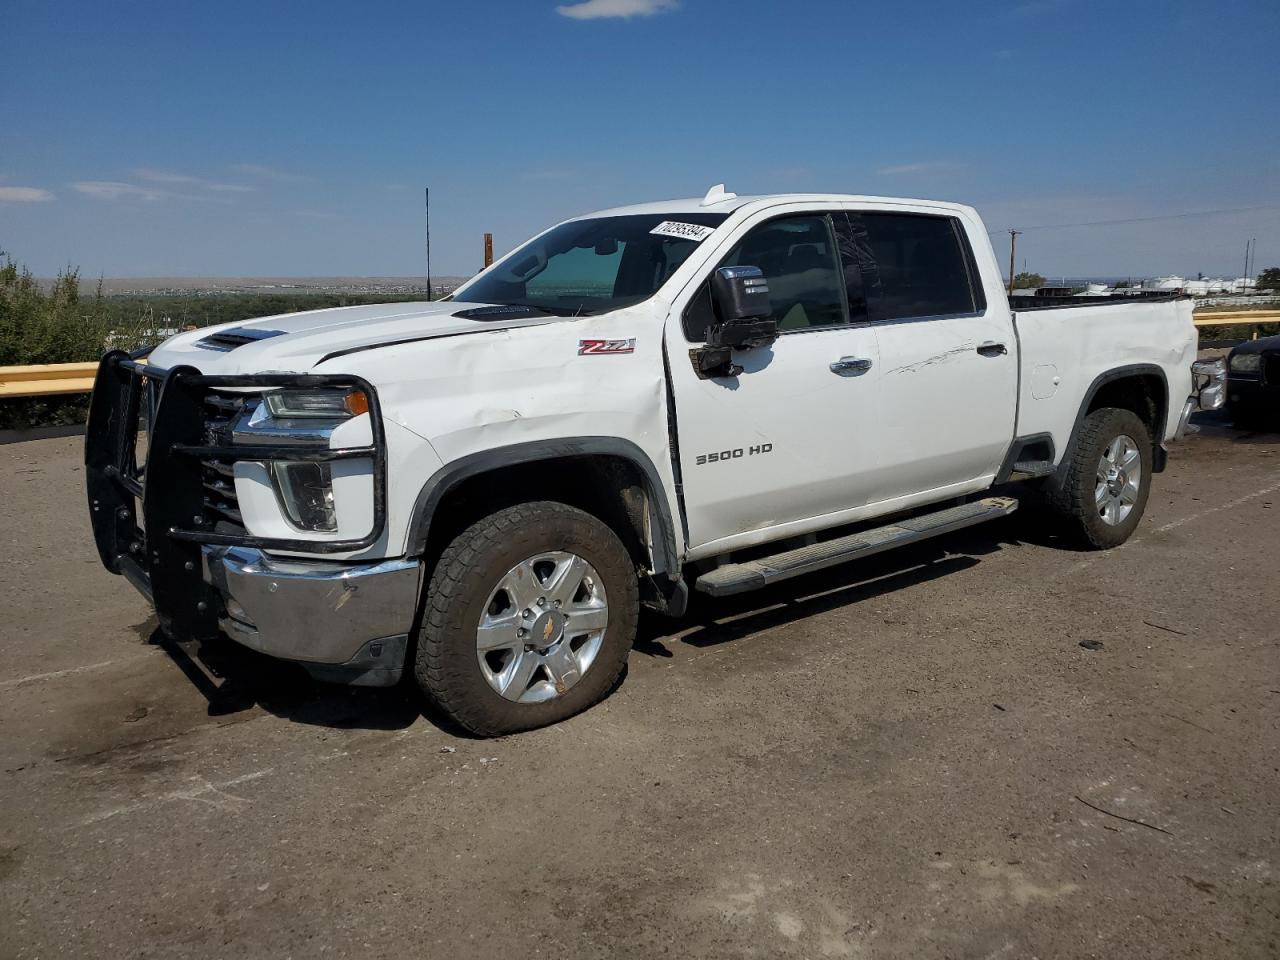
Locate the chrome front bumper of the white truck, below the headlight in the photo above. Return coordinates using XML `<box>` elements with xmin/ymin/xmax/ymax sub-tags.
<box><xmin>202</xmin><ymin>545</ymin><xmax>421</xmax><ymax>686</ymax></box>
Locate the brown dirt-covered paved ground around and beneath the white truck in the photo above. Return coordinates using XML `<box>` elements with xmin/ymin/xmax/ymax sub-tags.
<box><xmin>0</xmin><ymin>417</ymin><xmax>1280</xmax><ymax>960</ymax></box>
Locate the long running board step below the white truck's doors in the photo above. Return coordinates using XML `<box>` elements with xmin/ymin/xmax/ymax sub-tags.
<box><xmin>694</xmin><ymin>497</ymin><xmax>1018</xmax><ymax>596</ymax></box>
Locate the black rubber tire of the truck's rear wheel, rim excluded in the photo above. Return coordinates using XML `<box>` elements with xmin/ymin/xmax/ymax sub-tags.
<box><xmin>1050</xmin><ymin>407</ymin><xmax>1153</xmax><ymax>550</ymax></box>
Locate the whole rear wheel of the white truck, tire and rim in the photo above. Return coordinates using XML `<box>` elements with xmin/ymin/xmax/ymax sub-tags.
<box><xmin>1052</xmin><ymin>407</ymin><xmax>1152</xmax><ymax>550</ymax></box>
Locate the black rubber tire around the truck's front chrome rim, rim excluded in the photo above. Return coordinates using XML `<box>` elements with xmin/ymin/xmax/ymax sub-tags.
<box><xmin>413</xmin><ymin>500</ymin><xmax>639</xmax><ymax>737</ymax></box>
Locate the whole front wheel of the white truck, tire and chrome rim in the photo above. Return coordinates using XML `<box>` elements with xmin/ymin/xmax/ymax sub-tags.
<box><xmin>415</xmin><ymin>502</ymin><xmax>639</xmax><ymax>736</ymax></box>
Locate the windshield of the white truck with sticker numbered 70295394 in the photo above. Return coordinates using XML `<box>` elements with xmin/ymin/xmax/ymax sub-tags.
<box><xmin>453</xmin><ymin>212</ymin><xmax>727</xmax><ymax>316</ymax></box>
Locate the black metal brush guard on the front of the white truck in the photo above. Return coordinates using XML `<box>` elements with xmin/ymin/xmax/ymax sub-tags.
<box><xmin>84</xmin><ymin>351</ymin><xmax>387</xmax><ymax>640</ymax></box>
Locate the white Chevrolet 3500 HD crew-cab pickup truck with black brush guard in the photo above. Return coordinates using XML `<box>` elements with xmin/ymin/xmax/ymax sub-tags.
<box><xmin>86</xmin><ymin>187</ymin><xmax>1221</xmax><ymax>735</ymax></box>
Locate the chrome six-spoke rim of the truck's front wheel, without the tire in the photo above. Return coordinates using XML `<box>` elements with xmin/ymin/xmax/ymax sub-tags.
<box><xmin>476</xmin><ymin>552</ymin><xmax>609</xmax><ymax>703</ymax></box>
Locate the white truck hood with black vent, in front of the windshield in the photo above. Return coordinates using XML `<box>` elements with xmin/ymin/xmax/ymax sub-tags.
<box><xmin>147</xmin><ymin>301</ymin><xmax>570</xmax><ymax>374</ymax></box>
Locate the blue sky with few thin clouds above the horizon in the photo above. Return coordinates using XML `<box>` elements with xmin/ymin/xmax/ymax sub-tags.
<box><xmin>0</xmin><ymin>0</ymin><xmax>1280</xmax><ymax>276</ymax></box>
